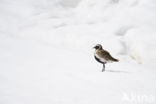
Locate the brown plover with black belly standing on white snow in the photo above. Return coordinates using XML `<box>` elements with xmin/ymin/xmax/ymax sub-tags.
<box><xmin>93</xmin><ymin>44</ymin><xmax>119</xmax><ymax>72</ymax></box>
